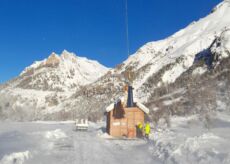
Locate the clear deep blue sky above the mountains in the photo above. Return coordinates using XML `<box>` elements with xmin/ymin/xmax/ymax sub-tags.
<box><xmin>0</xmin><ymin>0</ymin><xmax>221</xmax><ymax>83</ymax></box>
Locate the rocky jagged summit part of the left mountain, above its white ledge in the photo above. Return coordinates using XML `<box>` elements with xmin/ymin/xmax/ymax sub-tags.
<box><xmin>7</xmin><ymin>50</ymin><xmax>108</xmax><ymax>91</ymax></box>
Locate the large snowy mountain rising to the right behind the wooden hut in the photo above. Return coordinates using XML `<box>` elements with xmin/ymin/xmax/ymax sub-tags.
<box><xmin>69</xmin><ymin>0</ymin><xmax>230</xmax><ymax>120</ymax></box>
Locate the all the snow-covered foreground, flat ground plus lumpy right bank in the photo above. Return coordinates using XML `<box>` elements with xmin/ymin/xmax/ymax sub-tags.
<box><xmin>0</xmin><ymin>113</ymin><xmax>230</xmax><ymax>164</ymax></box>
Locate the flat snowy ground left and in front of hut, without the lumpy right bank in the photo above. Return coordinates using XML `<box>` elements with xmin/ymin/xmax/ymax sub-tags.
<box><xmin>0</xmin><ymin>123</ymin><xmax>160</xmax><ymax>164</ymax></box>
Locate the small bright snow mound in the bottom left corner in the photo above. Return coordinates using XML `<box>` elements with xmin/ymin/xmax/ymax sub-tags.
<box><xmin>0</xmin><ymin>151</ymin><xmax>31</xmax><ymax>164</ymax></box>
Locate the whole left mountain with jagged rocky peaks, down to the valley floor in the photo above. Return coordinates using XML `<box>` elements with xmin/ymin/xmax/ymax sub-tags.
<box><xmin>0</xmin><ymin>50</ymin><xmax>109</xmax><ymax>120</ymax></box>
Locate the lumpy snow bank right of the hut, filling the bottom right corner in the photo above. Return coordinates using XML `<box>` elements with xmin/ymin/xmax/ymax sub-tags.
<box><xmin>150</xmin><ymin>115</ymin><xmax>230</xmax><ymax>164</ymax></box>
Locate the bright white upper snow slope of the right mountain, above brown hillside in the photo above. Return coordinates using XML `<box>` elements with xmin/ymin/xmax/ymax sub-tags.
<box><xmin>112</xmin><ymin>0</ymin><xmax>230</xmax><ymax>100</ymax></box>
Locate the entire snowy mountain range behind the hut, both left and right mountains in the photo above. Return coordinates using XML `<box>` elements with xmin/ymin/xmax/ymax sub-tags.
<box><xmin>0</xmin><ymin>0</ymin><xmax>230</xmax><ymax>119</ymax></box>
